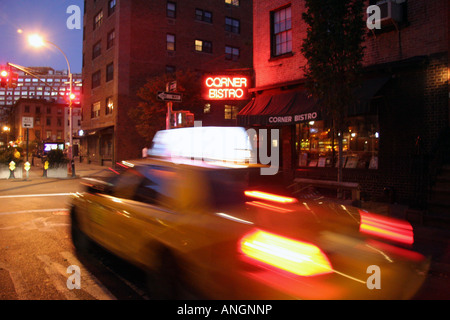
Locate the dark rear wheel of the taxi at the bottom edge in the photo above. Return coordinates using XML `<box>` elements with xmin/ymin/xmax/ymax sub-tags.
<box><xmin>147</xmin><ymin>251</ymin><xmax>181</xmax><ymax>300</ymax></box>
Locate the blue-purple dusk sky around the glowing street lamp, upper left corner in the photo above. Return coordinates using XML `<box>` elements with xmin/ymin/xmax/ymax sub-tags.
<box><xmin>0</xmin><ymin>0</ymin><xmax>83</xmax><ymax>73</ymax></box>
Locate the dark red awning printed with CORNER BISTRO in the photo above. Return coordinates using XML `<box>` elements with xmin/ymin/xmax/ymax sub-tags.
<box><xmin>237</xmin><ymin>90</ymin><xmax>320</xmax><ymax>126</ymax></box>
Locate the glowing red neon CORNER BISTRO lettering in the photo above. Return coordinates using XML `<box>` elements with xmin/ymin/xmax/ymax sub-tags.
<box><xmin>205</xmin><ymin>77</ymin><xmax>248</xmax><ymax>100</ymax></box>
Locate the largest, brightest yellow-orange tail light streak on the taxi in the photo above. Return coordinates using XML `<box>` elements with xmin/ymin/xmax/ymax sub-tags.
<box><xmin>239</xmin><ymin>230</ymin><xmax>333</xmax><ymax>277</ymax></box>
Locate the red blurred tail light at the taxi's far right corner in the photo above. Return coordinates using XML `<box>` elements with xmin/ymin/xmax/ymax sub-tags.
<box><xmin>359</xmin><ymin>210</ymin><xmax>414</xmax><ymax>245</ymax></box>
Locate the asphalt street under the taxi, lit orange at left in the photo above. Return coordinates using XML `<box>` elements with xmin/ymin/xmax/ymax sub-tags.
<box><xmin>0</xmin><ymin>162</ymin><xmax>450</xmax><ymax>300</ymax></box>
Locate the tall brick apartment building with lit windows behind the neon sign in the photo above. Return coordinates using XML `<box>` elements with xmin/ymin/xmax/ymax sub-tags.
<box><xmin>82</xmin><ymin>0</ymin><xmax>252</xmax><ymax>163</ymax></box>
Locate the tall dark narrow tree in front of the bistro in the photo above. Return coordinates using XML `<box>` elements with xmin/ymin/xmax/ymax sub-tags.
<box><xmin>302</xmin><ymin>0</ymin><xmax>366</xmax><ymax>194</ymax></box>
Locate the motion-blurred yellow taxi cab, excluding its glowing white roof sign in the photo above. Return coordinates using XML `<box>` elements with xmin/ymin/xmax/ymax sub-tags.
<box><xmin>71</xmin><ymin>129</ymin><xmax>429</xmax><ymax>299</ymax></box>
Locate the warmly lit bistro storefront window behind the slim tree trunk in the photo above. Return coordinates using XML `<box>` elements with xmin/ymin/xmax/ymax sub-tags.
<box><xmin>296</xmin><ymin>115</ymin><xmax>379</xmax><ymax>169</ymax></box>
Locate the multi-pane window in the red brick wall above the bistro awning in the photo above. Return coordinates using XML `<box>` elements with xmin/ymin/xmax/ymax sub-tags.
<box><xmin>272</xmin><ymin>7</ymin><xmax>292</xmax><ymax>56</ymax></box>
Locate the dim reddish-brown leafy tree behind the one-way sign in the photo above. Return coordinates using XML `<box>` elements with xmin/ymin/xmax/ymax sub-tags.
<box><xmin>129</xmin><ymin>70</ymin><xmax>201</xmax><ymax>143</ymax></box>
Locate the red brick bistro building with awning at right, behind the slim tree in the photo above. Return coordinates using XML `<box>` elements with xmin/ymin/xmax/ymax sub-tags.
<box><xmin>238</xmin><ymin>0</ymin><xmax>450</xmax><ymax>206</ymax></box>
